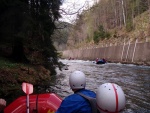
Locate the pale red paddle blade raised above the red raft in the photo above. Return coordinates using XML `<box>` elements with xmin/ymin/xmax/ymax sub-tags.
<box><xmin>22</xmin><ymin>82</ymin><xmax>33</xmax><ymax>95</ymax></box>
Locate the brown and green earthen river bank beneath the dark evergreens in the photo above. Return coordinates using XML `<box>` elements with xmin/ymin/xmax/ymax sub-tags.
<box><xmin>0</xmin><ymin>58</ymin><xmax>52</xmax><ymax>104</ymax></box>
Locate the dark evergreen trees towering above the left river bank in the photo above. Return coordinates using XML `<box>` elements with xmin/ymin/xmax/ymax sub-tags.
<box><xmin>0</xmin><ymin>0</ymin><xmax>62</xmax><ymax>74</ymax></box>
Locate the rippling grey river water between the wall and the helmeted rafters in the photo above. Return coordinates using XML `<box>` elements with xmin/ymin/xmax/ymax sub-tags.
<box><xmin>49</xmin><ymin>60</ymin><xmax>150</xmax><ymax>113</ymax></box>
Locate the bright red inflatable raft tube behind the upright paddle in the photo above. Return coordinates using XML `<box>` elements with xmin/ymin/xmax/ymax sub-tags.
<box><xmin>4</xmin><ymin>93</ymin><xmax>62</xmax><ymax>113</ymax></box>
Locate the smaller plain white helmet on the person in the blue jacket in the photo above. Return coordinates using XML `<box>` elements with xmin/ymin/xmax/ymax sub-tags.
<box><xmin>69</xmin><ymin>71</ymin><xmax>86</xmax><ymax>89</ymax></box>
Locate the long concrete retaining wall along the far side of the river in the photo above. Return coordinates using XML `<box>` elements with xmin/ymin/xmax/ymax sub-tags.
<box><xmin>62</xmin><ymin>41</ymin><xmax>150</xmax><ymax>66</ymax></box>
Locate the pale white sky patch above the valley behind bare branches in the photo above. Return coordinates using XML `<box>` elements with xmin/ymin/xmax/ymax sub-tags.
<box><xmin>60</xmin><ymin>0</ymin><xmax>95</xmax><ymax>23</ymax></box>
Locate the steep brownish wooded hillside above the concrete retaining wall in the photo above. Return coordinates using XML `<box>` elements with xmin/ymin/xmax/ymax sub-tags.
<box><xmin>67</xmin><ymin>0</ymin><xmax>150</xmax><ymax>49</ymax></box>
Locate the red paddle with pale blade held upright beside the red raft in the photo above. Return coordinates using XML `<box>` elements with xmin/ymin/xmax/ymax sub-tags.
<box><xmin>22</xmin><ymin>82</ymin><xmax>33</xmax><ymax>113</ymax></box>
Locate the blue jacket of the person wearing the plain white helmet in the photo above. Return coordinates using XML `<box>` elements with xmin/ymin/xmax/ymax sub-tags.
<box><xmin>56</xmin><ymin>89</ymin><xmax>96</xmax><ymax>113</ymax></box>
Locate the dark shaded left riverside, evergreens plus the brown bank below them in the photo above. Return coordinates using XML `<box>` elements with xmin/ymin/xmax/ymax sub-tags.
<box><xmin>0</xmin><ymin>0</ymin><xmax>63</xmax><ymax>103</ymax></box>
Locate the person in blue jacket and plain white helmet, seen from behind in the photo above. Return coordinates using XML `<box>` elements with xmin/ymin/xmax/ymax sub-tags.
<box><xmin>55</xmin><ymin>71</ymin><xmax>96</xmax><ymax>113</ymax></box>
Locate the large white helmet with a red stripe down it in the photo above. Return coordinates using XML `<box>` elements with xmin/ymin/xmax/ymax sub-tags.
<box><xmin>96</xmin><ymin>83</ymin><xmax>126</xmax><ymax>113</ymax></box>
